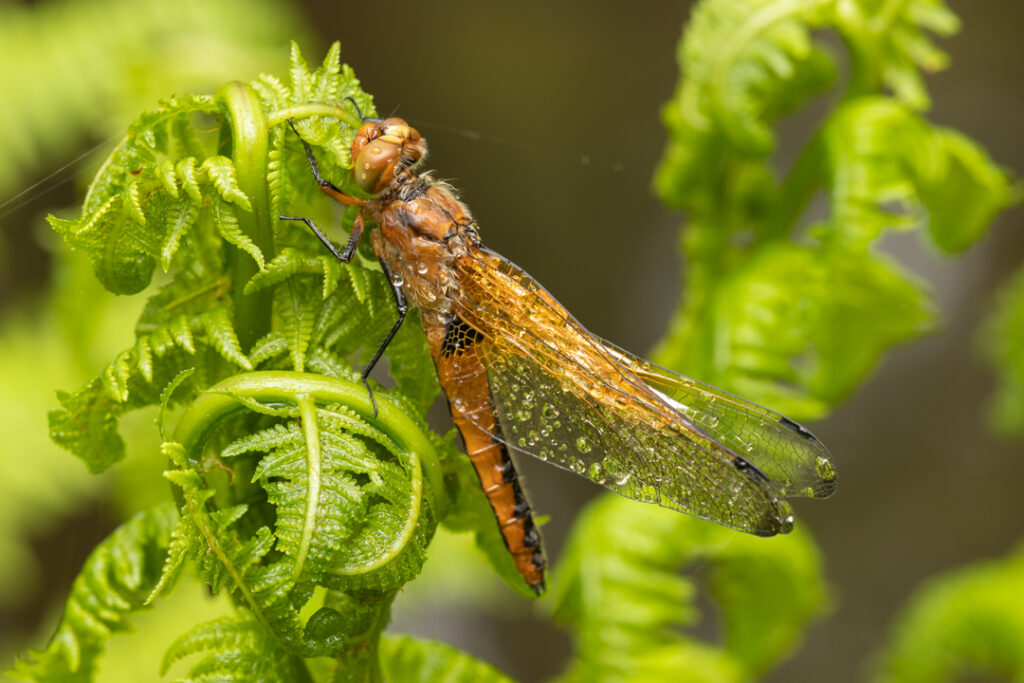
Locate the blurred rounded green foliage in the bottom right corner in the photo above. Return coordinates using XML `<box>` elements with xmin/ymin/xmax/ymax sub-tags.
<box><xmin>874</xmin><ymin>548</ymin><xmax>1024</xmax><ymax>683</ymax></box>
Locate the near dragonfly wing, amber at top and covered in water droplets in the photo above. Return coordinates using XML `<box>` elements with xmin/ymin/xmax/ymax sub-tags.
<box><xmin>455</xmin><ymin>250</ymin><xmax>792</xmax><ymax>536</ymax></box>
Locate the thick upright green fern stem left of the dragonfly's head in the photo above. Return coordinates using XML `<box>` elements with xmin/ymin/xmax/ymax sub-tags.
<box><xmin>217</xmin><ymin>82</ymin><xmax>274</xmax><ymax>350</ymax></box>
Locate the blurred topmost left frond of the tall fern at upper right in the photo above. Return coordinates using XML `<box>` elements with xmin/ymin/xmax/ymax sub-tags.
<box><xmin>654</xmin><ymin>0</ymin><xmax>835</xmax><ymax>209</ymax></box>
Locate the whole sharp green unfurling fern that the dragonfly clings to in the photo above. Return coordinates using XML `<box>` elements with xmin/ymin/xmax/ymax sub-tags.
<box><xmin>19</xmin><ymin>45</ymin><xmax>516</xmax><ymax>680</ymax></box>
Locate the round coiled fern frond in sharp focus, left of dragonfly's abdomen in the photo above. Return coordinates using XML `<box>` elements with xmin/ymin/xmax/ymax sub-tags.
<box><xmin>162</xmin><ymin>373</ymin><xmax>441</xmax><ymax>666</ymax></box>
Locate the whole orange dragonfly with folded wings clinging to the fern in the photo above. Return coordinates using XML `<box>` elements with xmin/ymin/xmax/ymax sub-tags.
<box><xmin>282</xmin><ymin>115</ymin><xmax>836</xmax><ymax>594</ymax></box>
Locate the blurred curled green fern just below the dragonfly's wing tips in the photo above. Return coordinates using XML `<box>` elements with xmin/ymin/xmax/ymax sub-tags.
<box><xmin>554</xmin><ymin>496</ymin><xmax>825</xmax><ymax>681</ymax></box>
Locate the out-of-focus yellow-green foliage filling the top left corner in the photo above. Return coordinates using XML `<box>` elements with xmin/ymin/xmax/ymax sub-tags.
<box><xmin>0</xmin><ymin>0</ymin><xmax>305</xmax><ymax>202</ymax></box>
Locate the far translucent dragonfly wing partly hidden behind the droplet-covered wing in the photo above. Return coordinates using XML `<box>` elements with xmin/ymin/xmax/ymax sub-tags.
<box><xmin>605</xmin><ymin>342</ymin><xmax>836</xmax><ymax>498</ymax></box>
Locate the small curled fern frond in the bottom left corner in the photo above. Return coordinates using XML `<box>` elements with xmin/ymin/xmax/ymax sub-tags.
<box><xmin>14</xmin><ymin>505</ymin><xmax>177</xmax><ymax>682</ymax></box>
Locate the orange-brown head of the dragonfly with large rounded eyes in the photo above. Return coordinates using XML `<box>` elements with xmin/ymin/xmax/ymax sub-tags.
<box><xmin>351</xmin><ymin>117</ymin><xmax>427</xmax><ymax>195</ymax></box>
